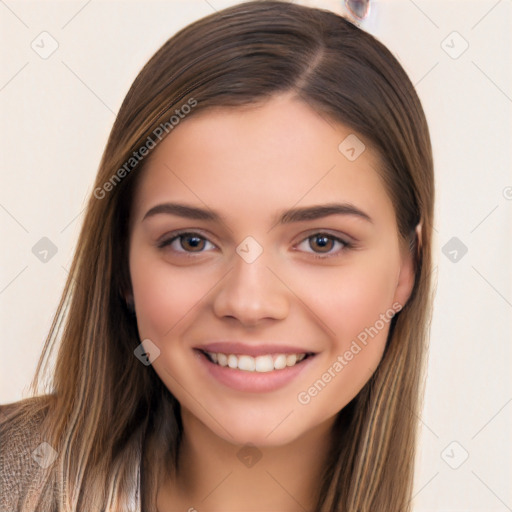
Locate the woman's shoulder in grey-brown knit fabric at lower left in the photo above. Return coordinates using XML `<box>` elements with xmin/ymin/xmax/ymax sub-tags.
<box><xmin>0</xmin><ymin>395</ymin><xmax>55</xmax><ymax>510</ymax></box>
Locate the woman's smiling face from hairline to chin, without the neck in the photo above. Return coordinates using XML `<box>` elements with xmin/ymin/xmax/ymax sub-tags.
<box><xmin>129</xmin><ymin>94</ymin><xmax>414</xmax><ymax>446</ymax></box>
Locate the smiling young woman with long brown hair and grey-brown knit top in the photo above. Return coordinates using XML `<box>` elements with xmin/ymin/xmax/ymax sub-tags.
<box><xmin>0</xmin><ymin>1</ymin><xmax>434</xmax><ymax>512</ymax></box>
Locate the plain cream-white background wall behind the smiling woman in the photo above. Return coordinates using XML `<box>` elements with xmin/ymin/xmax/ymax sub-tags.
<box><xmin>0</xmin><ymin>0</ymin><xmax>512</xmax><ymax>512</ymax></box>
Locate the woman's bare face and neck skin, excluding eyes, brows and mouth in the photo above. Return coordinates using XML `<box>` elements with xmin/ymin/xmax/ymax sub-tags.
<box><xmin>129</xmin><ymin>94</ymin><xmax>414</xmax><ymax>512</ymax></box>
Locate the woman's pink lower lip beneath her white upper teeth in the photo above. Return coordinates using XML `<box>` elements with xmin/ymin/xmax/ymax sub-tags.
<box><xmin>195</xmin><ymin>350</ymin><xmax>315</xmax><ymax>393</ymax></box>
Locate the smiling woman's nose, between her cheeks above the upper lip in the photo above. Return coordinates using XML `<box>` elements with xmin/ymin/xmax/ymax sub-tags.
<box><xmin>213</xmin><ymin>253</ymin><xmax>290</xmax><ymax>326</ymax></box>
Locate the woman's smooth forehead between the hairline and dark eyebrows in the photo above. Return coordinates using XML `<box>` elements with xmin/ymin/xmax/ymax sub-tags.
<box><xmin>130</xmin><ymin>94</ymin><xmax>394</xmax><ymax>228</ymax></box>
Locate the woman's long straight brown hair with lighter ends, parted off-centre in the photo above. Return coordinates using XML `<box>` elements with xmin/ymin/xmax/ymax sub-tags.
<box><xmin>6</xmin><ymin>1</ymin><xmax>434</xmax><ymax>512</ymax></box>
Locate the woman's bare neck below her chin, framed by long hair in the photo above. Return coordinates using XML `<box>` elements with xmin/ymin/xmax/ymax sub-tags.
<box><xmin>157</xmin><ymin>410</ymin><xmax>333</xmax><ymax>512</ymax></box>
